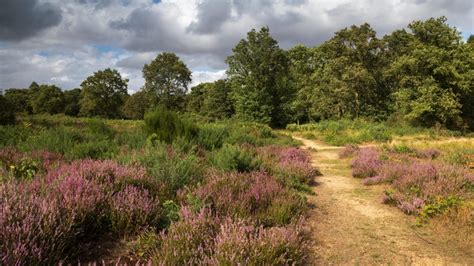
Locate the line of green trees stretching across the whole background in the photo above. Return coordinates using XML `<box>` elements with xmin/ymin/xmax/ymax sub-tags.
<box><xmin>0</xmin><ymin>17</ymin><xmax>474</xmax><ymax>130</ymax></box>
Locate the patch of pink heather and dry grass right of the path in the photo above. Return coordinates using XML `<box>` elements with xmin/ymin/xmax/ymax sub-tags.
<box><xmin>346</xmin><ymin>145</ymin><xmax>474</xmax><ymax>220</ymax></box>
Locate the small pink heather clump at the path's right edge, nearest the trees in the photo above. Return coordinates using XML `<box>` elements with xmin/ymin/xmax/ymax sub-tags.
<box><xmin>351</xmin><ymin>148</ymin><xmax>382</xmax><ymax>178</ymax></box>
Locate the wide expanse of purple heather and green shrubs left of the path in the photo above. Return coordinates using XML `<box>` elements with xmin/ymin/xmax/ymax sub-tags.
<box><xmin>0</xmin><ymin>114</ymin><xmax>318</xmax><ymax>265</ymax></box>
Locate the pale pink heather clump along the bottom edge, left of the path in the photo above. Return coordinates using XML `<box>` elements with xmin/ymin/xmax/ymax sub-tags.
<box><xmin>153</xmin><ymin>207</ymin><xmax>307</xmax><ymax>265</ymax></box>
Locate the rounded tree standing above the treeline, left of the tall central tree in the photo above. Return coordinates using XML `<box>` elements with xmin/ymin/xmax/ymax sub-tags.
<box><xmin>143</xmin><ymin>52</ymin><xmax>191</xmax><ymax>110</ymax></box>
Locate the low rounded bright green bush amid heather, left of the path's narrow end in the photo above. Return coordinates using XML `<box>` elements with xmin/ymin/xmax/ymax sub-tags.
<box><xmin>210</xmin><ymin>144</ymin><xmax>262</xmax><ymax>172</ymax></box>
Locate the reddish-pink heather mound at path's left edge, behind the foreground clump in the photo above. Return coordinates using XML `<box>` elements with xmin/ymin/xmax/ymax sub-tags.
<box><xmin>194</xmin><ymin>172</ymin><xmax>304</xmax><ymax>225</ymax></box>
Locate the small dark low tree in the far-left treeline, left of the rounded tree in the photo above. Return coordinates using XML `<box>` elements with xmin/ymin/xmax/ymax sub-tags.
<box><xmin>30</xmin><ymin>84</ymin><xmax>64</xmax><ymax>114</ymax></box>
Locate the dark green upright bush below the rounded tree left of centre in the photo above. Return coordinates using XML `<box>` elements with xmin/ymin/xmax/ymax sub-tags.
<box><xmin>144</xmin><ymin>107</ymin><xmax>198</xmax><ymax>144</ymax></box>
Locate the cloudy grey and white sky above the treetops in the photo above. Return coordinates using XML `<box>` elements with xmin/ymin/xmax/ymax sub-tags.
<box><xmin>0</xmin><ymin>0</ymin><xmax>474</xmax><ymax>93</ymax></box>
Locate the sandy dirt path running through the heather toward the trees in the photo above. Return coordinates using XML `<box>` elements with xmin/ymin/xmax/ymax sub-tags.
<box><xmin>294</xmin><ymin>137</ymin><xmax>474</xmax><ymax>265</ymax></box>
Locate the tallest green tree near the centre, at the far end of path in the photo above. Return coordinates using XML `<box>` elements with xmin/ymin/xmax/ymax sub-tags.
<box><xmin>226</xmin><ymin>27</ymin><xmax>292</xmax><ymax>126</ymax></box>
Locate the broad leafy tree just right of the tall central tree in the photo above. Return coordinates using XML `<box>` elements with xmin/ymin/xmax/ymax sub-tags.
<box><xmin>313</xmin><ymin>23</ymin><xmax>389</xmax><ymax>119</ymax></box>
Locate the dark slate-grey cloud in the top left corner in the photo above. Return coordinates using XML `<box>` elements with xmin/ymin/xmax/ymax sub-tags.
<box><xmin>0</xmin><ymin>0</ymin><xmax>62</xmax><ymax>41</ymax></box>
